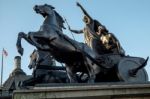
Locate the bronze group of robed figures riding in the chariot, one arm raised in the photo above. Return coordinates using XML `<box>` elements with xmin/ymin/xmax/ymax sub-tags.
<box><xmin>69</xmin><ymin>2</ymin><xmax>125</xmax><ymax>56</ymax></box>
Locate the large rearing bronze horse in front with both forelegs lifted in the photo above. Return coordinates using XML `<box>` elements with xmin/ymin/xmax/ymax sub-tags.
<box><xmin>16</xmin><ymin>4</ymin><xmax>103</xmax><ymax>82</ymax></box>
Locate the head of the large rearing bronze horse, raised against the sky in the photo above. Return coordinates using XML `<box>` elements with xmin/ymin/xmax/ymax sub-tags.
<box><xmin>33</xmin><ymin>4</ymin><xmax>55</xmax><ymax>17</ymax></box>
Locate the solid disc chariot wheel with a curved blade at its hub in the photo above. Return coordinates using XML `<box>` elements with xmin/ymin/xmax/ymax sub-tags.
<box><xmin>117</xmin><ymin>58</ymin><xmax>148</xmax><ymax>82</ymax></box>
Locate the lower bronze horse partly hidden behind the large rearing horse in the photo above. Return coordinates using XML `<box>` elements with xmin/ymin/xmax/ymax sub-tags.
<box><xmin>19</xmin><ymin>49</ymin><xmax>68</xmax><ymax>87</ymax></box>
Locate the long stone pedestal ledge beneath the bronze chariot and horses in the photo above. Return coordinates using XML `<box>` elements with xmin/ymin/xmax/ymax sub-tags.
<box><xmin>13</xmin><ymin>83</ymin><xmax>150</xmax><ymax>99</ymax></box>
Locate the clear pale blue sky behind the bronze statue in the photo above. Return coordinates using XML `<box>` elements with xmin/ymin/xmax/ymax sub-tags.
<box><xmin>0</xmin><ymin>0</ymin><xmax>150</xmax><ymax>81</ymax></box>
